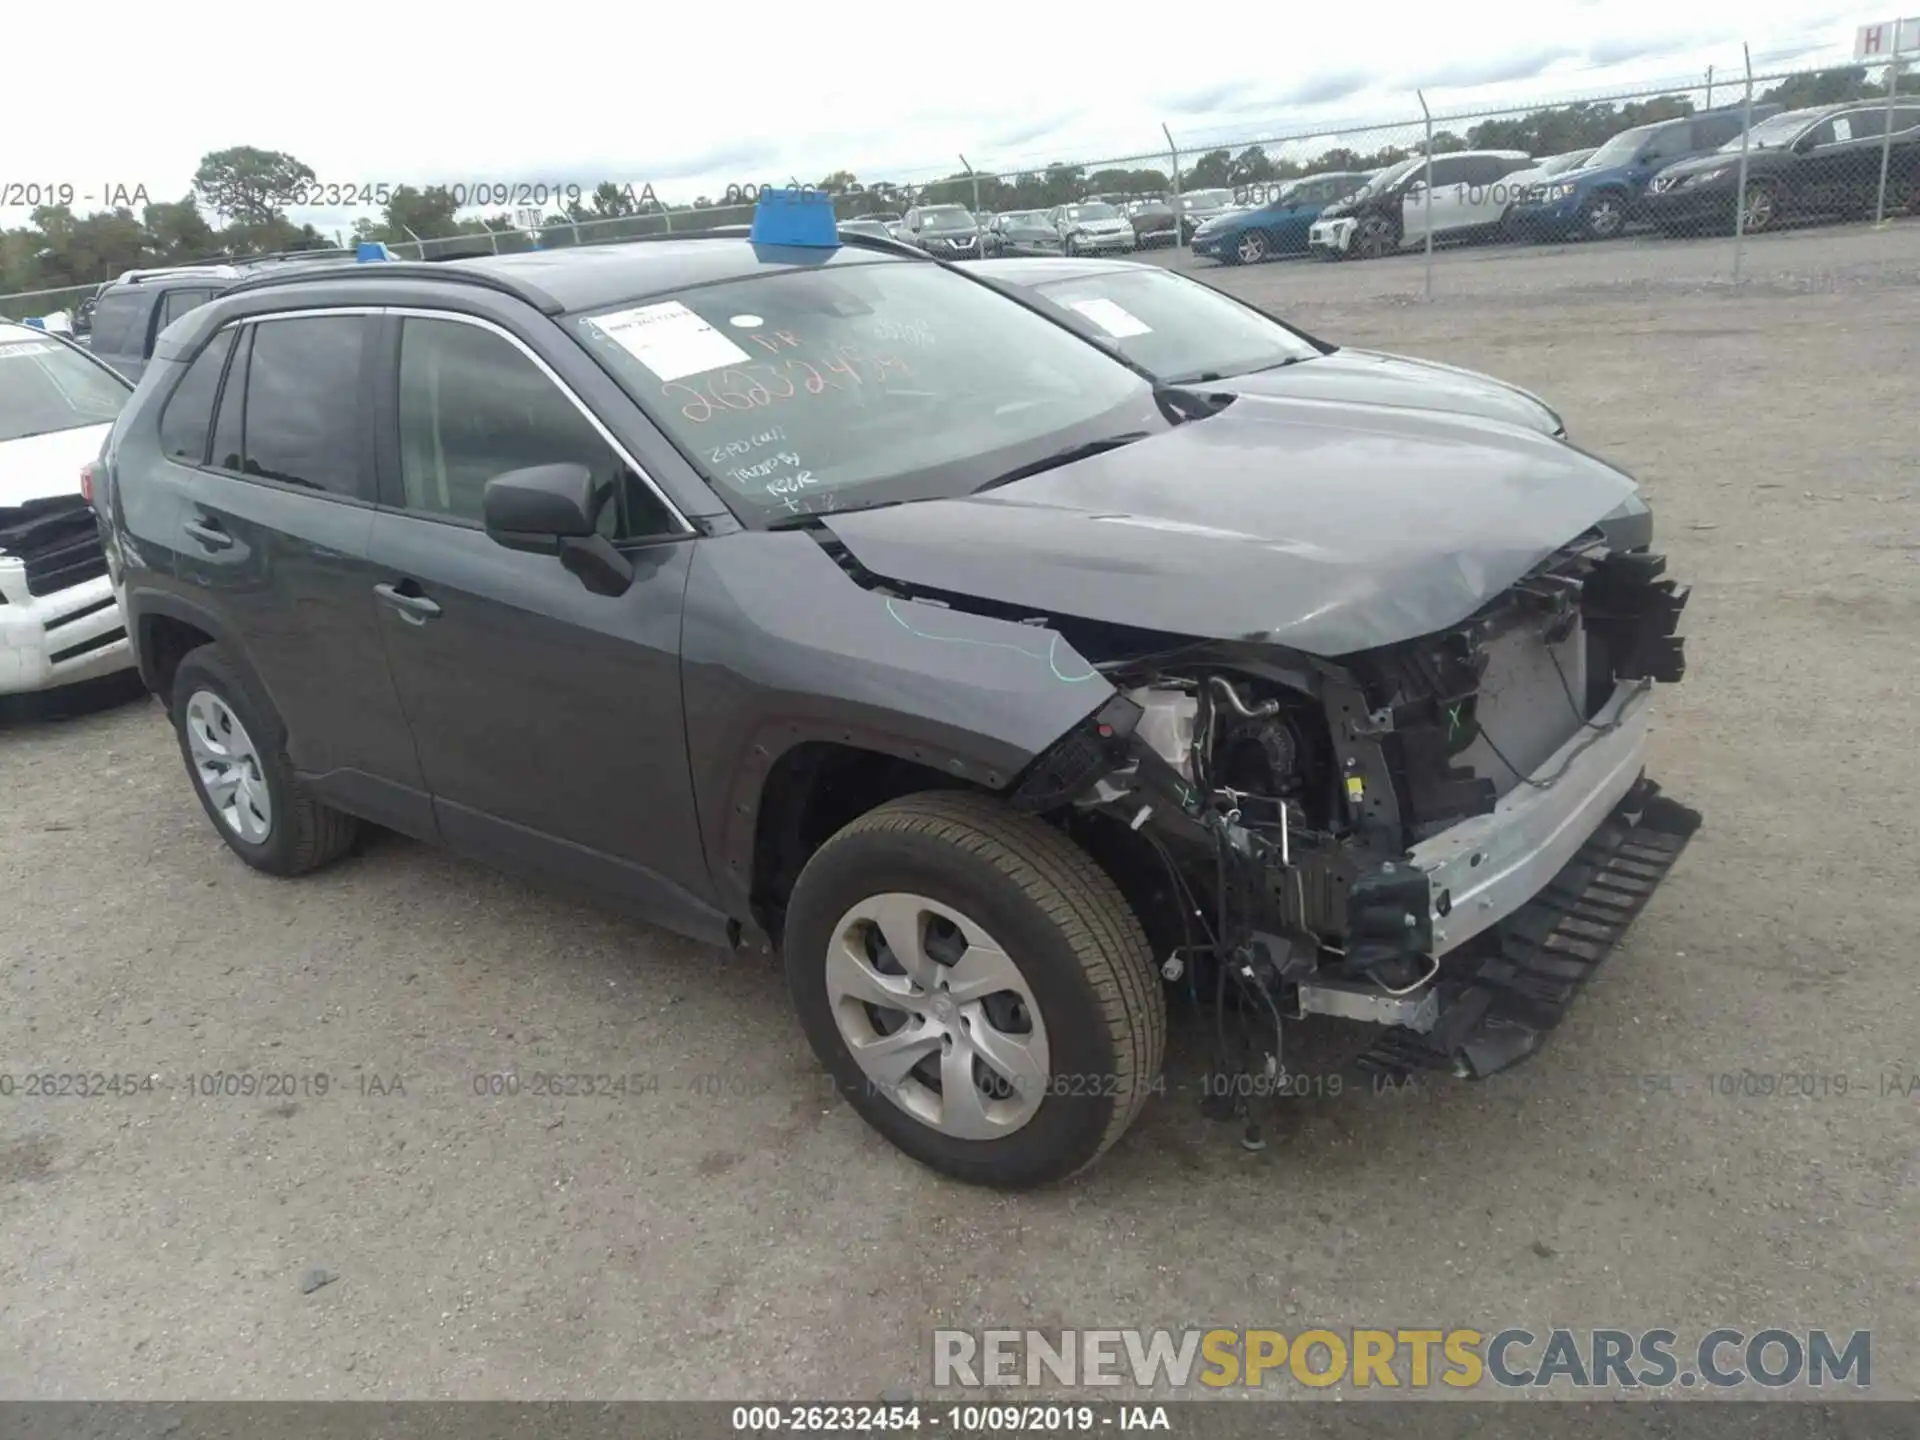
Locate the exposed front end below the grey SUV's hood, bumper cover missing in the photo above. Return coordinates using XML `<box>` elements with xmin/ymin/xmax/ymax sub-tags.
<box><xmin>1012</xmin><ymin>530</ymin><xmax>1693</xmax><ymax>1085</ymax></box>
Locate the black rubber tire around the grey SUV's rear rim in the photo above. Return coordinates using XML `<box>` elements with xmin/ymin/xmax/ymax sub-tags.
<box><xmin>167</xmin><ymin>645</ymin><xmax>359</xmax><ymax>876</ymax></box>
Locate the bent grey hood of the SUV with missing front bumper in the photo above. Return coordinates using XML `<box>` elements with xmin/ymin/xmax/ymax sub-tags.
<box><xmin>824</xmin><ymin>397</ymin><xmax>1638</xmax><ymax>657</ymax></box>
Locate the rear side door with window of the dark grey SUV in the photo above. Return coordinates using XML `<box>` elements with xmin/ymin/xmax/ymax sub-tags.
<box><xmin>159</xmin><ymin>313</ymin><xmax>432</xmax><ymax>837</ymax></box>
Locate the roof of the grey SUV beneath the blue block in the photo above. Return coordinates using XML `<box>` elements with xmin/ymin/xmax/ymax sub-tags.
<box><xmin>227</xmin><ymin>234</ymin><xmax>917</xmax><ymax>315</ymax></box>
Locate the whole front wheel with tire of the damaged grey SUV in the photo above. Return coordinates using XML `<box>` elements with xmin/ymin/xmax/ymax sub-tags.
<box><xmin>783</xmin><ymin>791</ymin><xmax>1167</xmax><ymax>1188</ymax></box>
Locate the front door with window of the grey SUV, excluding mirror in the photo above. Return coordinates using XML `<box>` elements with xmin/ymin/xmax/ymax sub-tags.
<box><xmin>369</xmin><ymin>311</ymin><xmax>718</xmax><ymax>933</ymax></box>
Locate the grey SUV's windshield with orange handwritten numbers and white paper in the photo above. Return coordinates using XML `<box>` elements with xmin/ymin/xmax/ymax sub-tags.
<box><xmin>568</xmin><ymin>261</ymin><xmax>1167</xmax><ymax>524</ymax></box>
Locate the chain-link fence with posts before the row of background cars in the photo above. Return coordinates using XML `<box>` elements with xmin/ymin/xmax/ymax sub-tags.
<box><xmin>0</xmin><ymin>52</ymin><xmax>1920</xmax><ymax>319</ymax></box>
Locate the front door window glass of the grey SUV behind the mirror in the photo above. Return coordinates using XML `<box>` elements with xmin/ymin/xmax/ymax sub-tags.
<box><xmin>399</xmin><ymin>317</ymin><xmax>676</xmax><ymax>540</ymax></box>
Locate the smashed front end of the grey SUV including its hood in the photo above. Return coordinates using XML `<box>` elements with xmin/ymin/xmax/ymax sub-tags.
<box><xmin>810</xmin><ymin>405</ymin><xmax>1697</xmax><ymax>1121</ymax></box>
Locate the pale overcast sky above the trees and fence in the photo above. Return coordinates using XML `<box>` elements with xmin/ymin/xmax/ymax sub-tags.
<box><xmin>0</xmin><ymin>0</ymin><xmax>1889</xmax><ymax>230</ymax></box>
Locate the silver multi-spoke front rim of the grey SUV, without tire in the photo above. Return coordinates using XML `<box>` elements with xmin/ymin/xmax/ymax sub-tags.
<box><xmin>826</xmin><ymin>891</ymin><xmax>1050</xmax><ymax>1140</ymax></box>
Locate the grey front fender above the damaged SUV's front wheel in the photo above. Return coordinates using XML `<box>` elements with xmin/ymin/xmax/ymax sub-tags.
<box><xmin>682</xmin><ymin>530</ymin><xmax>1114</xmax><ymax>918</ymax></box>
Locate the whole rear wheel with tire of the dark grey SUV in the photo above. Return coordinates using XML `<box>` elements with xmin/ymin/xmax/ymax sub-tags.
<box><xmin>169</xmin><ymin>645</ymin><xmax>359</xmax><ymax>876</ymax></box>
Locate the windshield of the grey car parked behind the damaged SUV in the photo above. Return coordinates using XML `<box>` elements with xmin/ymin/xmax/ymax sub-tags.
<box><xmin>1037</xmin><ymin>267</ymin><xmax>1321</xmax><ymax>384</ymax></box>
